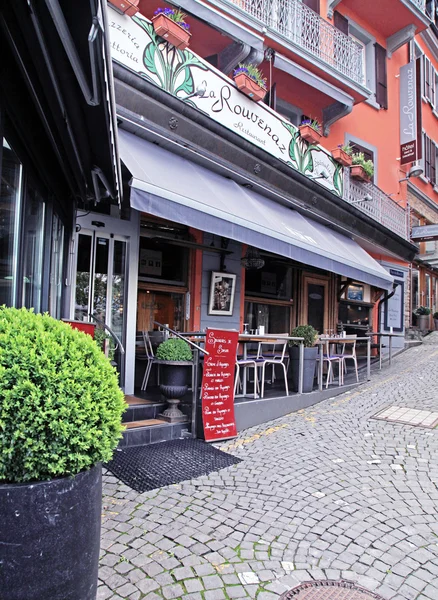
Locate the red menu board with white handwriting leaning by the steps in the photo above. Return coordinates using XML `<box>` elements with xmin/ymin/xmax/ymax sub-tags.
<box><xmin>202</xmin><ymin>329</ymin><xmax>239</xmax><ymax>442</ymax></box>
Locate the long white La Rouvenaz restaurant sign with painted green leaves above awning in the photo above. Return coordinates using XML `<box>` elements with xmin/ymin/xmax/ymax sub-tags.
<box><xmin>109</xmin><ymin>10</ymin><xmax>343</xmax><ymax>197</ymax></box>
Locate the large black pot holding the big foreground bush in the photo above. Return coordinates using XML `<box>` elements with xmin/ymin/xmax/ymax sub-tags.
<box><xmin>0</xmin><ymin>464</ymin><xmax>102</xmax><ymax>600</ymax></box>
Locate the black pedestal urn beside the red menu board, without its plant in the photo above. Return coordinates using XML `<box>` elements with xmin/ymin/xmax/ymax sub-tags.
<box><xmin>157</xmin><ymin>360</ymin><xmax>193</xmax><ymax>423</ymax></box>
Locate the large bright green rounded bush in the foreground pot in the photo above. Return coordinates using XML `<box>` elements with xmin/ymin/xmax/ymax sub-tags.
<box><xmin>0</xmin><ymin>306</ymin><xmax>126</xmax><ymax>483</ymax></box>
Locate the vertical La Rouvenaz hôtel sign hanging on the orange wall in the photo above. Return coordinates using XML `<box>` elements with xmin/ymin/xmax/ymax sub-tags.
<box><xmin>400</xmin><ymin>59</ymin><xmax>422</xmax><ymax>165</ymax></box>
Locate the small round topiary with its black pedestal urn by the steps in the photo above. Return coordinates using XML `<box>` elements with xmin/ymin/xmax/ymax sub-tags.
<box><xmin>155</xmin><ymin>338</ymin><xmax>193</xmax><ymax>423</ymax></box>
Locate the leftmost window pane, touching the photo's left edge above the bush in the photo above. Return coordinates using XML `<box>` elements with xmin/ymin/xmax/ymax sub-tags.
<box><xmin>0</xmin><ymin>140</ymin><xmax>22</xmax><ymax>306</ymax></box>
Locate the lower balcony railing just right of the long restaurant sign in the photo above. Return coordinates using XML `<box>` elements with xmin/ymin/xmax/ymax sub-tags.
<box><xmin>344</xmin><ymin>169</ymin><xmax>409</xmax><ymax>240</ymax></box>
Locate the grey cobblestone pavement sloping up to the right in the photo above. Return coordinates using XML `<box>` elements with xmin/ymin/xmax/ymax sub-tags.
<box><xmin>98</xmin><ymin>333</ymin><xmax>438</xmax><ymax>600</ymax></box>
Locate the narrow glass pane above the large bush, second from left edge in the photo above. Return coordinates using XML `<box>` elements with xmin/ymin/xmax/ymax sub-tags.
<box><xmin>23</xmin><ymin>183</ymin><xmax>45</xmax><ymax>312</ymax></box>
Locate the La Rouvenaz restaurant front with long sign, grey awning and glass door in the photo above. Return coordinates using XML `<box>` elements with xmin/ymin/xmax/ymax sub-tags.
<box><xmin>62</xmin><ymin>5</ymin><xmax>416</xmax><ymax>394</ymax></box>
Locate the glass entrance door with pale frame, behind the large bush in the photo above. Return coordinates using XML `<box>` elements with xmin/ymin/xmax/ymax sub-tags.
<box><xmin>74</xmin><ymin>230</ymin><xmax>127</xmax><ymax>383</ymax></box>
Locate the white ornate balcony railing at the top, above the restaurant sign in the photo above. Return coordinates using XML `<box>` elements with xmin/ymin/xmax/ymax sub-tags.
<box><xmin>222</xmin><ymin>0</ymin><xmax>364</xmax><ymax>84</ymax></box>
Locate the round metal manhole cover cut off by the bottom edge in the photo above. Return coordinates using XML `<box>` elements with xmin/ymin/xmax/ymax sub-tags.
<box><xmin>280</xmin><ymin>580</ymin><xmax>383</xmax><ymax>600</ymax></box>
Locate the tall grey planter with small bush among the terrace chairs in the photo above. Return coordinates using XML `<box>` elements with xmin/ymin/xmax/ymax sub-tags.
<box><xmin>289</xmin><ymin>325</ymin><xmax>318</xmax><ymax>393</ymax></box>
